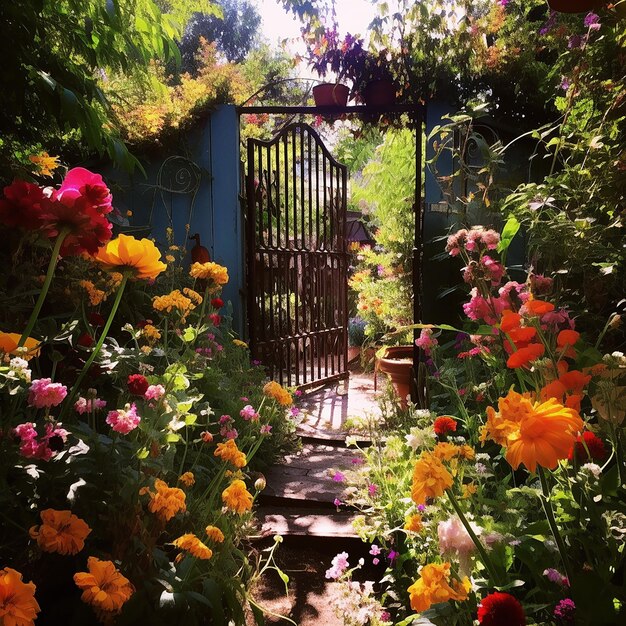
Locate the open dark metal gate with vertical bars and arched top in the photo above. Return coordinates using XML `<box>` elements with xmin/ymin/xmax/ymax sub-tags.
<box><xmin>246</xmin><ymin>123</ymin><xmax>348</xmax><ymax>388</ymax></box>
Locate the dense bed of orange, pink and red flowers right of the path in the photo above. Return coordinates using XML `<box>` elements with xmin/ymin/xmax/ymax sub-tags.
<box><xmin>327</xmin><ymin>224</ymin><xmax>626</xmax><ymax>626</ymax></box>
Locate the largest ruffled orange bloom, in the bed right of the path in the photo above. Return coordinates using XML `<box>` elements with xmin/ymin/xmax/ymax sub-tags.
<box><xmin>483</xmin><ymin>390</ymin><xmax>583</xmax><ymax>472</ymax></box>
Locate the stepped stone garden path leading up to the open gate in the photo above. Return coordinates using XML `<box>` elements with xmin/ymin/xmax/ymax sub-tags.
<box><xmin>249</xmin><ymin>372</ymin><xmax>384</xmax><ymax>626</ymax></box>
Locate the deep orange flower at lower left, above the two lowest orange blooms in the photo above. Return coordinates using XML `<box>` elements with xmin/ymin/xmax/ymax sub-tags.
<box><xmin>29</xmin><ymin>509</ymin><xmax>91</xmax><ymax>554</ymax></box>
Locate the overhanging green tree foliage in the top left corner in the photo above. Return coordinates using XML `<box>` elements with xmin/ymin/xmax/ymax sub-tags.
<box><xmin>0</xmin><ymin>0</ymin><xmax>179</xmax><ymax>180</ymax></box>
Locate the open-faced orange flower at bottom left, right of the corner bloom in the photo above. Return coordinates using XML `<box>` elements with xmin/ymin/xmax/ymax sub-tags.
<box><xmin>74</xmin><ymin>556</ymin><xmax>135</xmax><ymax>619</ymax></box>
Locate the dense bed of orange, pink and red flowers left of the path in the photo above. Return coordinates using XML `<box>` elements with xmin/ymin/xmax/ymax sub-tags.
<box><xmin>0</xmin><ymin>168</ymin><xmax>297</xmax><ymax>625</ymax></box>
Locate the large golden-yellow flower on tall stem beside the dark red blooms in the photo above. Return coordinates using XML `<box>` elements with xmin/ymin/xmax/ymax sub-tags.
<box><xmin>93</xmin><ymin>235</ymin><xmax>167</xmax><ymax>280</ymax></box>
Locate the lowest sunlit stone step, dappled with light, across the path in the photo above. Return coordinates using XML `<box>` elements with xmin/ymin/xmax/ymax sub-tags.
<box><xmin>257</xmin><ymin>506</ymin><xmax>358</xmax><ymax>539</ymax></box>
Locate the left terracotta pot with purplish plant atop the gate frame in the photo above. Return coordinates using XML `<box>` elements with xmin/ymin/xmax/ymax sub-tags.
<box><xmin>309</xmin><ymin>28</ymin><xmax>366</xmax><ymax>106</ymax></box>
